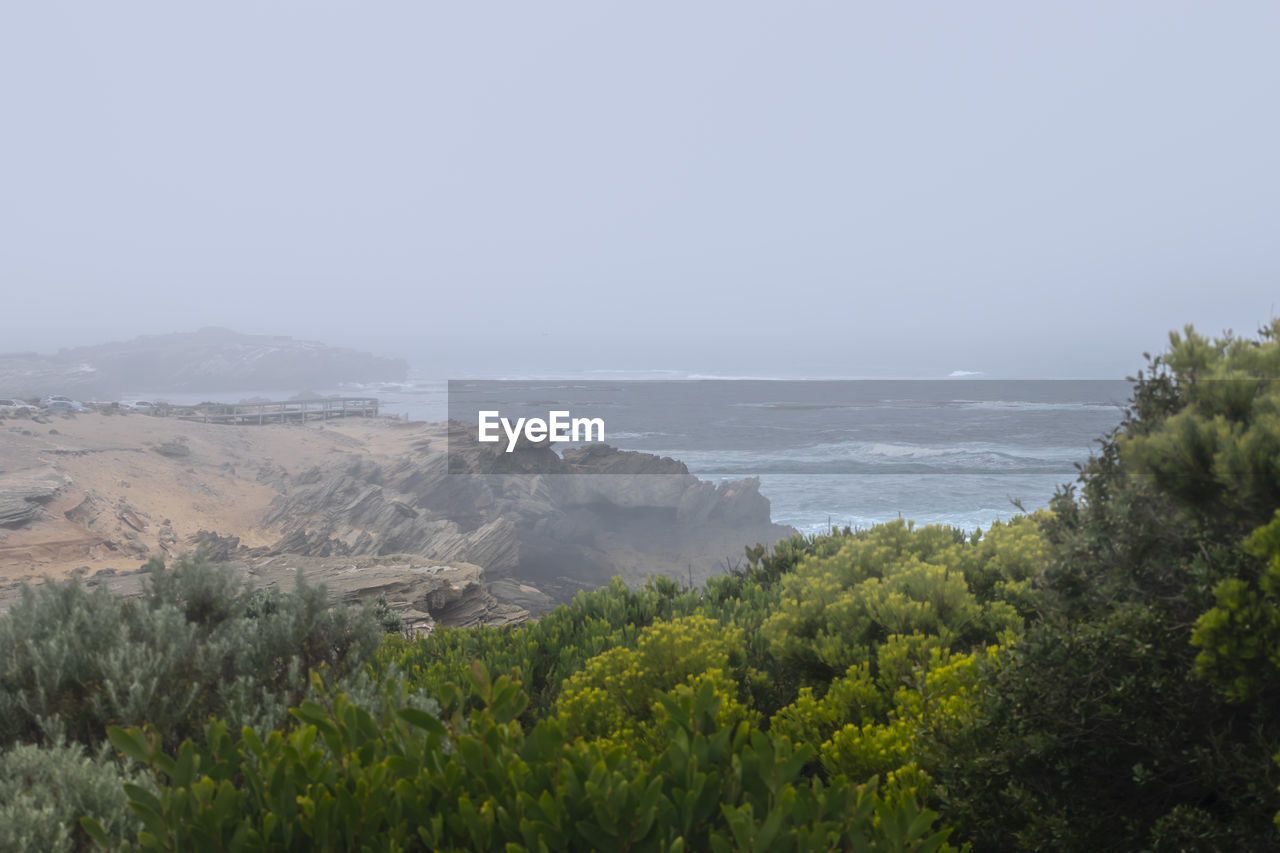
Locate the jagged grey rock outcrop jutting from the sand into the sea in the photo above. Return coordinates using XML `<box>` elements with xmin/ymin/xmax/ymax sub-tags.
<box><xmin>257</xmin><ymin>422</ymin><xmax>791</xmax><ymax>598</ymax></box>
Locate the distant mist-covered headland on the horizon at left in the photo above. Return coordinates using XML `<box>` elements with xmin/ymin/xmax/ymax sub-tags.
<box><xmin>0</xmin><ymin>328</ymin><xmax>408</xmax><ymax>397</ymax></box>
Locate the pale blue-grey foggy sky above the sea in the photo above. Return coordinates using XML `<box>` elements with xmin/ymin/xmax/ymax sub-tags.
<box><xmin>0</xmin><ymin>0</ymin><xmax>1280</xmax><ymax>378</ymax></box>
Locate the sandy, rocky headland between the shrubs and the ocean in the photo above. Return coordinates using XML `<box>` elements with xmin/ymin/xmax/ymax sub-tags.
<box><xmin>0</xmin><ymin>414</ymin><xmax>792</xmax><ymax>626</ymax></box>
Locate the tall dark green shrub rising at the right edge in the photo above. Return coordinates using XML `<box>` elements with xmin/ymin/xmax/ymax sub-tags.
<box><xmin>931</xmin><ymin>321</ymin><xmax>1280</xmax><ymax>850</ymax></box>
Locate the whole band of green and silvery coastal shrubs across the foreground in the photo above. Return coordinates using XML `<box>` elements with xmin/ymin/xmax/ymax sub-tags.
<box><xmin>0</xmin><ymin>321</ymin><xmax>1280</xmax><ymax>852</ymax></box>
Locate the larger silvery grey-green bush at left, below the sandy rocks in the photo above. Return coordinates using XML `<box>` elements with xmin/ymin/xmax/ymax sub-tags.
<box><xmin>0</xmin><ymin>557</ymin><xmax>384</xmax><ymax>745</ymax></box>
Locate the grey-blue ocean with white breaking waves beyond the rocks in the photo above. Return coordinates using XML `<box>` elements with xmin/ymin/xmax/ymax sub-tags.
<box><xmin>343</xmin><ymin>378</ymin><xmax>1132</xmax><ymax>533</ymax></box>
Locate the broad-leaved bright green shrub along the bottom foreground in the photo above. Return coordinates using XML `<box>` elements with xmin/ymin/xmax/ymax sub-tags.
<box><xmin>97</xmin><ymin>666</ymin><xmax>951</xmax><ymax>853</ymax></box>
